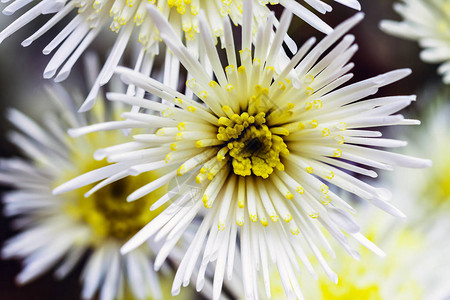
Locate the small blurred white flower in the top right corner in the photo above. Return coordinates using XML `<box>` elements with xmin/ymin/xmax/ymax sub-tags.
<box><xmin>380</xmin><ymin>0</ymin><xmax>450</xmax><ymax>84</ymax></box>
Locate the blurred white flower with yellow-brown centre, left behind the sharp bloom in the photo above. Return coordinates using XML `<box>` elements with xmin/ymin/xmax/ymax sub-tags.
<box><xmin>0</xmin><ymin>83</ymin><xmax>187</xmax><ymax>299</ymax></box>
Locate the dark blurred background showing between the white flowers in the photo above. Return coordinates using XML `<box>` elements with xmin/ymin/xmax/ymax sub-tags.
<box><xmin>0</xmin><ymin>0</ymin><xmax>442</xmax><ymax>300</ymax></box>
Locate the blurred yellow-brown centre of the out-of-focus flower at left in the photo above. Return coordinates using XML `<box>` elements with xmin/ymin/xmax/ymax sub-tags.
<box><xmin>62</xmin><ymin>133</ymin><xmax>167</xmax><ymax>241</ymax></box>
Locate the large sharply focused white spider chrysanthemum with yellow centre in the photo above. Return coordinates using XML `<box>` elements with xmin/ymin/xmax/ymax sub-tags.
<box><xmin>54</xmin><ymin>5</ymin><xmax>431</xmax><ymax>299</ymax></box>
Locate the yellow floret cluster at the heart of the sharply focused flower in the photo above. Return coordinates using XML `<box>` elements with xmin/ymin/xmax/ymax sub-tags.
<box><xmin>212</xmin><ymin>78</ymin><xmax>289</xmax><ymax>178</ymax></box>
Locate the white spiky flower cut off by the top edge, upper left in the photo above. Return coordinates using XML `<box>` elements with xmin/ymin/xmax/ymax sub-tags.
<box><xmin>0</xmin><ymin>0</ymin><xmax>360</xmax><ymax>111</ymax></box>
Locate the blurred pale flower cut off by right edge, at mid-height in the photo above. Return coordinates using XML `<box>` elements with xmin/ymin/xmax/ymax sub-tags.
<box><xmin>387</xmin><ymin>98</ymin><xmax>450</xmax><ymax>222</ymax></box>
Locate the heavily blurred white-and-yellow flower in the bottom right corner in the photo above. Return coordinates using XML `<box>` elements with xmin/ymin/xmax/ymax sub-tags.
<box><xmin>272</xmin><ymin>209</ymin><xmax>450</xmax><ymax>300</ymax></box>
